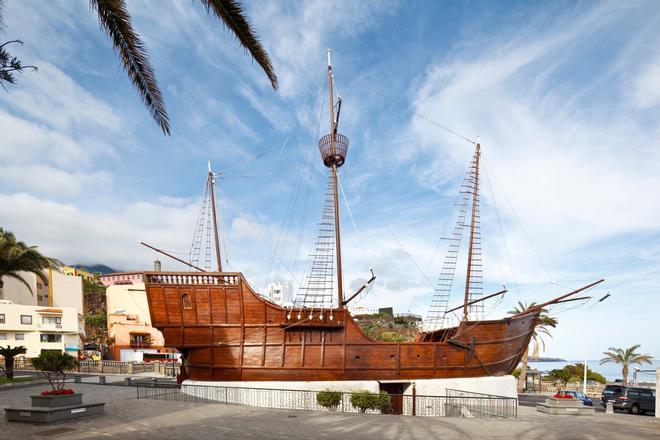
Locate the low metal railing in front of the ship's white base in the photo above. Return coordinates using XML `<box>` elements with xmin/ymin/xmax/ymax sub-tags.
<box><xmin>136</xmin><ymin>384</ymin><xmax>518</xmax><ymax>419</ymax></box>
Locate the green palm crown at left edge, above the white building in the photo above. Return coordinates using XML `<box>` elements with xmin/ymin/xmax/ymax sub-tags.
<box><xmin>0</xmin><ymin>228</ymin><xmax>61</xmax><ymax>298</ymax></box>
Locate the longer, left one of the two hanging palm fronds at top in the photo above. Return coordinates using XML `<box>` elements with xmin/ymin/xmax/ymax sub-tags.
<box><xmin>90</xmin><ymin>0</ymin><xmax>170</xmax><ymax>135</ymax></box>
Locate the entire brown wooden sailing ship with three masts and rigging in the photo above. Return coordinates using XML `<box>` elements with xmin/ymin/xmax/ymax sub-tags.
<box><xmin>144</xmin><ymin>54</ymin><xmax>602</xmax><ymax>381</ymax></box>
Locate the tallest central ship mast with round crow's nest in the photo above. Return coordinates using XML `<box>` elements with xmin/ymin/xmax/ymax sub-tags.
<box><xmin>319</xmin><ymin>49</ymin><xmax>348</xmax><ymax>309</ymax></box>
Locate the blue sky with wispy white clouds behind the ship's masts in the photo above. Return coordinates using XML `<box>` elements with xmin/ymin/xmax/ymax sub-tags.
<box><xmin>0</xmin><ymin>0</ymin><xmax>660</xmax><ymax>358</ymax></box>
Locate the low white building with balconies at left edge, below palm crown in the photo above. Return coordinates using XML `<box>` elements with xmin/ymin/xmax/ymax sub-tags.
<box><xmin>0</xmin><ymin>300</ymin><xmax>85</xmax><ymax>357</ymax></box>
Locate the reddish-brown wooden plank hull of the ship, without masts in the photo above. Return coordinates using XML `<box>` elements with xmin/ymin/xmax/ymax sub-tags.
<box><xmin>144</xmin><ymin>272</ymin><xmax>538</xmax><ymax>381</ymax></box>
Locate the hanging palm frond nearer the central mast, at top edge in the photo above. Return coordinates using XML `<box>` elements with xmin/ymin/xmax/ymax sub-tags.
<box><xmin>202</xmin><ymin>0</ymin><xmax>277</xmax><ymax>89</ymax></box>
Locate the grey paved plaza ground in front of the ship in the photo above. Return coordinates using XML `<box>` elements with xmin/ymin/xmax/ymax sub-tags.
<box><xmin>0</xmin><ymin>384</ymin><xmax>660</xmax><ymax>440</ymax></box>
